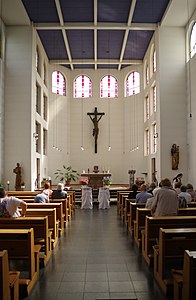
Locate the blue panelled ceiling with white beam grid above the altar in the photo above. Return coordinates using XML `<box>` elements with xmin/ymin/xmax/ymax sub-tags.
<box><xmin>22</xmin><ymin>0</ymin><xmax>169</xmax><ymax>70</ymax></box>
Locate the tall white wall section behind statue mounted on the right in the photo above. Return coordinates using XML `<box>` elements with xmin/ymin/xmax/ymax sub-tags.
<box><xmin>158</xmin><ymin>27</ymin><xmax>187</xmax><ymax>183</ymax></box>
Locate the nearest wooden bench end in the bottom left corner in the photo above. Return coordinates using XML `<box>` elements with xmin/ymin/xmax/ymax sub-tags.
<box><xmin>0</xmin><ymin>250</ymin><xmax>20</xmax><ymax>300</ymax></box>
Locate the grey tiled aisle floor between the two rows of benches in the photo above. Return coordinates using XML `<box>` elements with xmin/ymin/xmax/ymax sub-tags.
<box><xmin>28</xmin><ymin>205</ymin><xmax>172</xmax><ymax>300</ymax></box>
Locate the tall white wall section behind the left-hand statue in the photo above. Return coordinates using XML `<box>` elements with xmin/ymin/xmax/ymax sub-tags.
<box><xmin>4</xmin><ymin>26</ymin><xmax>32</xmax><ymax>189</ymax></box>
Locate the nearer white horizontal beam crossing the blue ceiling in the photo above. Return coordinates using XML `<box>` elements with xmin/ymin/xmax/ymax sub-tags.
<box><xmin>33</xmin><ymin>23</ymin><xmax>157</xmax><ymax>30</ymax></box>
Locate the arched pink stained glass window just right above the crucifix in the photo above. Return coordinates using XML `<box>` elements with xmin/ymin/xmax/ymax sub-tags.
<box><xmin>100</xmin><ymin>75</ymin><xmax>118</xmax><ymax>98</ymax></box>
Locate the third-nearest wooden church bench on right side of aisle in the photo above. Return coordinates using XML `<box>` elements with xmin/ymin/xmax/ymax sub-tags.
<box><xmin>142</xmin><ymin>216</ymin><xmax>196</xmax><ymax>266</ymax></box>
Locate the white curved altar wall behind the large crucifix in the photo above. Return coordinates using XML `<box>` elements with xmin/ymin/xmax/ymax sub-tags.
<box><xmin>48</xmin><ymin>66</ymin><xmax>146</xmax><ymax>183</ymax></box>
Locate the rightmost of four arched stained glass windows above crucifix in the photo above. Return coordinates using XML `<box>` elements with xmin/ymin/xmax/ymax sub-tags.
<box><xmin>126</xmin><ymin>71</ymin><xmax>140</xmax><ymax>97</ymax></box>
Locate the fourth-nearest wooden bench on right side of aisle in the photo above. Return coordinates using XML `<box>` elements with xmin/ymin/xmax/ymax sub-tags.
<box><xmin>133</xmin><ymin>207</ymin><xmax>151</xmax><ymax>248</ymax></box>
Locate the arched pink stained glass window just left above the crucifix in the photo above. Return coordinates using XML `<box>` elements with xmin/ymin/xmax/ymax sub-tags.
<box><xmin>74</xmin><ymin>75</ymin><xmax>92</xmax><ymax>98</ymax></box>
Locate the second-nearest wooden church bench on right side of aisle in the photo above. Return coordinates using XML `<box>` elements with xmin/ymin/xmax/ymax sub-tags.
<box><xmin>153</xmin><ymin>228</ymin><xmax>196</xmax><ymax>295</ymax></box>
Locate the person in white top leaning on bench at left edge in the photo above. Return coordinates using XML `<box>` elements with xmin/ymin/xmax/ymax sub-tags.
<box><xmin>0</xmin><ymin>188</ymin><xmax>27</xmax><ymax>218</ymax></box>
